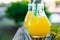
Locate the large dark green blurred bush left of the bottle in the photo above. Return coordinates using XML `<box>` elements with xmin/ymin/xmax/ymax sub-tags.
<box><xmin>6</xmin><ymin>2</ymin><xmax>28</xmax><ymax>23</ymax></box>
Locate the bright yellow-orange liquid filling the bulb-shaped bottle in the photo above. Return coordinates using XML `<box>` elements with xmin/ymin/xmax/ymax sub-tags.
<box><xmin>24</xmin><ymin>12</ymin><xmax>50</xmax><ymax>37</ymax></box>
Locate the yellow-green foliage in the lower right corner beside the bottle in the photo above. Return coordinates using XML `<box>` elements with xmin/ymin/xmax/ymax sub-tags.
<box><xmin>51</xmin><ymin>23</ymin><xmax>60</xmax><ymax>40</ymax></box>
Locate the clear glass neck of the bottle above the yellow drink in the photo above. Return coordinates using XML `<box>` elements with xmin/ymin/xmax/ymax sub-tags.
<box><xmin>28</xmin><ymin>2</ymin><xmax>45</xmax><ymax>15</ymax></box>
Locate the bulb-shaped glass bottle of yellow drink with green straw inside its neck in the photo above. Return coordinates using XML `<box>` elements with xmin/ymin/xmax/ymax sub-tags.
<box><xmin>24</xmin><ymin>1</ymin><xmax>50</xmax><ymax>38</ymax></box>
